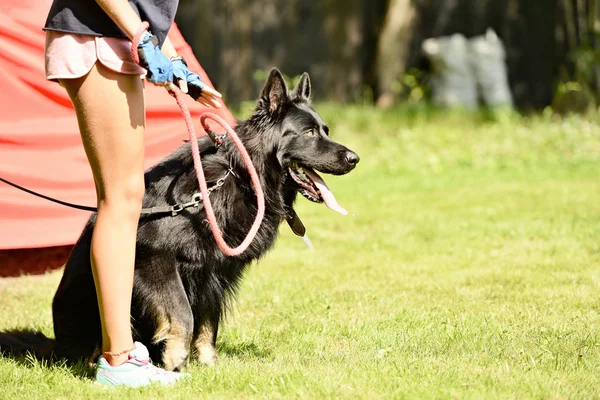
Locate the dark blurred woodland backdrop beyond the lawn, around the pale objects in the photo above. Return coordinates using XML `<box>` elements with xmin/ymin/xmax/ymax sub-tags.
<box><xmin>177</xmin><ymin>0</ymin><xmax>600</xmax><ymax>108</ymax></box>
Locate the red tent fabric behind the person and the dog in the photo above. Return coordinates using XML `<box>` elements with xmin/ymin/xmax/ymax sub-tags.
<box><xmin>0</xmin><ymin>0</ymin><xmax>233</xmax><ymax>253</ymax></box>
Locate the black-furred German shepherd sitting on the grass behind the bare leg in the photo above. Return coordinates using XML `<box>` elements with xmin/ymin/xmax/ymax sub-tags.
<box><xmin>0</xmin><ymin>69</ymin><xmax>358</xmax><ymax>370</ymax></box>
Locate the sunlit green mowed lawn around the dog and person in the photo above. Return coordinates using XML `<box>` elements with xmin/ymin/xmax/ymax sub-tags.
<box><xmin>0</xmin><ymin>104</ymin><xmax>600</xmax><ymax>399</ymax></box>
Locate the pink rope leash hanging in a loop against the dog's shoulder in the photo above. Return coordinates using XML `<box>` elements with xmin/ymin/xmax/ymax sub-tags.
<box><xmin>131</xmin><ymin>22</ymin><xmax>265</xmax><ymax>256</ymax></box>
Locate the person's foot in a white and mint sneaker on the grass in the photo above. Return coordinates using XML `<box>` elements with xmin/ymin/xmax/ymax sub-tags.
<box><xmin>96</xmin><ymin>342</ymin><xmax>188</xmax><ymax>387</ymax></box>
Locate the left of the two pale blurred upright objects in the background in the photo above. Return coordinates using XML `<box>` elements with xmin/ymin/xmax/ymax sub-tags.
<box><xmin>422</xmin><ymin>33</ymin><xmax>477</xmax><ymax>108</ymax></box>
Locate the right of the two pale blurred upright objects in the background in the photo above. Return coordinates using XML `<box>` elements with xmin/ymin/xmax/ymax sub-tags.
<box><xmin>469</xmin><ymin>28</ymin><xmax>513</xmax><ymax>108</ymax></box>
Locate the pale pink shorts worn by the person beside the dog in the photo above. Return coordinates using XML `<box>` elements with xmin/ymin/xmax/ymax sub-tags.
<box><xmin>46</xmin><ymin>31</ymin><xmax>146</xmax><ymax>81</ymax></box>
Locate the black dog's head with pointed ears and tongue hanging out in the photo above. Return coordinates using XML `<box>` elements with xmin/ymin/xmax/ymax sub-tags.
<box><xmin>255</xmin><ymin>69</ymin><xmax>359</xmax><ymax>214</ymax></box>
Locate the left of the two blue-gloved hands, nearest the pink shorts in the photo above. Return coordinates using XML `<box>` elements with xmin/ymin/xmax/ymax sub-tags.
<box><xmin>138</xmin><ymin>32</ymin><xmax>173</xmax><ymax>86</ymax></box>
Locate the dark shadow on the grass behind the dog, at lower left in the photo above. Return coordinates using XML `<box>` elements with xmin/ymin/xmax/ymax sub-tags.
<box><xmin>0</xmin><ymin>329</ymin><xmax>94</xmax><ymax>380</ymax></box>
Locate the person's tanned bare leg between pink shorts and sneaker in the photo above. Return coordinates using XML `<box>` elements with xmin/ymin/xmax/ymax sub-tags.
<box><xmin>61</xmin><ymin>63</ymin><xmax>145</xmax><ymax>365</ymax></box>
